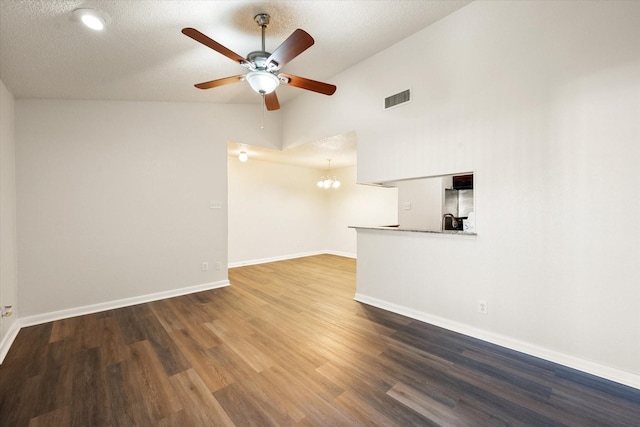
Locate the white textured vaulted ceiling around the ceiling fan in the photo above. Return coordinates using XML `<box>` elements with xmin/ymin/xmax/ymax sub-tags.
<box><xmin>0</xmin><ymin>0</ymin><xmax>469</xmax><ymax>167</ymax></box>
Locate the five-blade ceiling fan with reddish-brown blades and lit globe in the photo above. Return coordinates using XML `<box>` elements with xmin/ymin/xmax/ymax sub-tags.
<box><xmin>182</xmin><ymin>13</ymin><xmax>336</xmax><ymax>111</ymax></box>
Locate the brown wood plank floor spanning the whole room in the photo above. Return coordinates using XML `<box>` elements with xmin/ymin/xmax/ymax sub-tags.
<box><xmin>0</xmin><ymin>255</ymin><xmax>640</xmax><ymax>427</ymax></box>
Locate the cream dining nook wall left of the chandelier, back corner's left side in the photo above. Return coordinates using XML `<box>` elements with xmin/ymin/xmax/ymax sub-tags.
<box><xmin>228</xmin><ymin>156</ymin><xmax>327</xmax><ymax>267</ymax></box>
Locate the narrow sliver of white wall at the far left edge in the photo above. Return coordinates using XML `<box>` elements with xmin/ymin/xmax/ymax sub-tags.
<box><xmin>0</xmin><ymin>81</ymin><xmax>18</xmax><ymax>362</ymax></box>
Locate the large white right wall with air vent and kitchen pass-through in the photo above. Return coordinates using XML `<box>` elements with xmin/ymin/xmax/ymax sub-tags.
<box><xmin>283</xmin><ymin>1</ymin><xmax>640</xmax><ymax>387</ymax></box>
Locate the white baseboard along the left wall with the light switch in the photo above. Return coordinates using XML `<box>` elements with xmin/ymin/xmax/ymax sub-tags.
<box><xmin>20</xmin><ymin>280</ymin><xmax>229</xmax><ymax>327</ymax></box>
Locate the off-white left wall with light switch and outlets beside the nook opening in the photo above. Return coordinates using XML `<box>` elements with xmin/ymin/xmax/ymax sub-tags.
<box><xmin>16</xmin><ymin>100</ymin><xmax>280</xmax><ymax>319</ymax></box>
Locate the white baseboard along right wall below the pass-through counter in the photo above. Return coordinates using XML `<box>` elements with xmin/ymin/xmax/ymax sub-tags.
<box><xmin>353</xmin><ymin>293</ymin><xmax>640</xmax><ymax>389</ymax></box>
